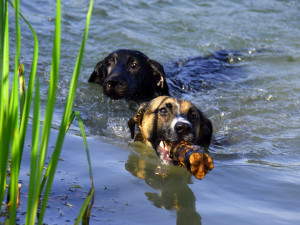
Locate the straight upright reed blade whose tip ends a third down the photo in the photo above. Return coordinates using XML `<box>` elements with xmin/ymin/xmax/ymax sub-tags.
<box><xmin>26</xmin><ymin>77</ymin><xmax>41</xmax><ymax>224</ymax></box>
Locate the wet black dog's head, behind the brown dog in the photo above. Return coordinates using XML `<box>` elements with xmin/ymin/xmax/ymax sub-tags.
<box><xmin>89</xmin><ymin>49</ymin><xmax>169</xmax><ymax>99</ymax></box>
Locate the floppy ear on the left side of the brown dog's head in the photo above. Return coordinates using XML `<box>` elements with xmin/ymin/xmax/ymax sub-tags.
<box><xmin>128</xmin><ymin>103</ymin><xmax>148</xmax><ymax>141</ymax></box>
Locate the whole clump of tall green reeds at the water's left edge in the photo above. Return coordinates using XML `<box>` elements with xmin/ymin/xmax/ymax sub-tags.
<box><xmin>0</xmin><ymin>0</ymin><xmax>94</xmax><ymax>224</ymax></box>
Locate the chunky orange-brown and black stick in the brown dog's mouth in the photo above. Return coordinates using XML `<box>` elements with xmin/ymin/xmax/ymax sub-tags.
<box><xmin>157</xmin><ymin>141</ymin><xmax>214</xmax><ymax>180</ymax></box>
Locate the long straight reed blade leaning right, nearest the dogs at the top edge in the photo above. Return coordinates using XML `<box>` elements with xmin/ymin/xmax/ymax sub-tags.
<box><xmin>39</xmin><ymin>0</ymin><xmax>94</xmax><ymax>221</ymax></box>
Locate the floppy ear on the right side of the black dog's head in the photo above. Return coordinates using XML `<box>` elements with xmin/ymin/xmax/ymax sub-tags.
<box><xmin>148</xmin><ymin>59</ymin><xmax>170</xmax><ymax>95</ymax></box>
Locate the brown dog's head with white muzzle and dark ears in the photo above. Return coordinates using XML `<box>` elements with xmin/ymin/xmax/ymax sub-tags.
<box><xmin>128</xmin><ymin>96</ymin><xmax>213</xmax><ymax>163</ymax></box>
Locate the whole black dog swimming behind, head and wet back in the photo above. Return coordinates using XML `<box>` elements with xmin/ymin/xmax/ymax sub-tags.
<box><xmin>88</xmin><ymin>49</ymin><xmax>243</xmax><ymax>101</ymax></box>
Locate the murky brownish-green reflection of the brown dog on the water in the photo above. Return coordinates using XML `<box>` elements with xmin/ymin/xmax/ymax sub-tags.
<box><xmin>125</xmin><ymin>143</ymin><xmax>201</xmax><ymax>225</ymax></box>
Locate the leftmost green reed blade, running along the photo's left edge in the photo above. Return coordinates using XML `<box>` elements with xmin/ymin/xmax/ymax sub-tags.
<box><xmin>0</xmin><ymin>0</ymin><xmax>10</xmax><ymax>211</ymax></box>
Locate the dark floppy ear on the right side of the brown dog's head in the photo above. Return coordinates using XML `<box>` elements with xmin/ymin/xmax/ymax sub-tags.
<box><xmin>197</xmin><ymin>110</ymin><xmax>213</xmax><ymax>146</ymax></box>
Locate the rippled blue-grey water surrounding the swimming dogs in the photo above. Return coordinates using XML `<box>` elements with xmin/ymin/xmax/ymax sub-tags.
<box><xmin>6</xmin><ymin>0</ymin><xmax>300</xmax><ymax>224</ymax></box>
